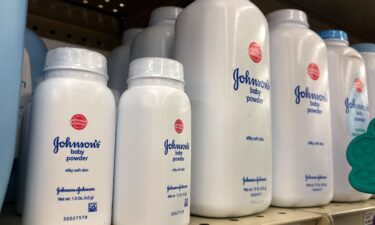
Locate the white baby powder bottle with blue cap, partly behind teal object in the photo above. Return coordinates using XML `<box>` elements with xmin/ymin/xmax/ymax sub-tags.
<box><xmin>319</xmin><ymin>30</ymin><xmax>370</xmax><ymax>202</ymax></box>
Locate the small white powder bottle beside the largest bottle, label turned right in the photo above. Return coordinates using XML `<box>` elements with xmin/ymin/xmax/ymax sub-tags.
<box><xmin>113</xmin><ymin>58</ymin><xmax>191</xmax><ymax>225</ymax></box>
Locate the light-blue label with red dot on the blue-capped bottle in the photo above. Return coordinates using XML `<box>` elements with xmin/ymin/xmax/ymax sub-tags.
<box><xmin>344</xmin><ymin>77</ymin><xmax>369</xmax><ymax>139</ymax></box>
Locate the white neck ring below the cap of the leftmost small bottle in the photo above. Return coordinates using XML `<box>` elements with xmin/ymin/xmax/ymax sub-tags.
<box><xmin>44</xmin><ymin>69</ymin><xmax>108</xmax><ymax>86</ymax></box>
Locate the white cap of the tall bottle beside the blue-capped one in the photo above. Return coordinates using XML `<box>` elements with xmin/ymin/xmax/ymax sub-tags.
<box><xmin>267</xmin><ymin>9</ymin><xmax>309</xmax><ymax>27</ymax></box>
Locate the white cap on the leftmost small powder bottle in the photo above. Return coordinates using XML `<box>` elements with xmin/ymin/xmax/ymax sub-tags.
<box><xmin>43</xmin><ymin>48</ymin><xmax>108</xmax><ymax>79</ymax></box>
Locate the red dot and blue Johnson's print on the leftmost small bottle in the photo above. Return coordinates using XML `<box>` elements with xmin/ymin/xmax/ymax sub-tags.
<box><xmin>50</xmin><ymin>113</ymin><xmax>111</xmax><ymax>223</ymax></box>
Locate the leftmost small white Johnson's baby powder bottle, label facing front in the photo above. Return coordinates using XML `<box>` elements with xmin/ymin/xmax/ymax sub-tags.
<box><xmin>23</xmin><ymin>48</ymin><xmax>116</xmax><ymax>225</ymax></box>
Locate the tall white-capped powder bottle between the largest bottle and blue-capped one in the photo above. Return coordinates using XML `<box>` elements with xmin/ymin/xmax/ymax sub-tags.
<box><xmin>267</xmin><ymin>9</ymin><xmax>333</xmax><ymax>207</ymax></box>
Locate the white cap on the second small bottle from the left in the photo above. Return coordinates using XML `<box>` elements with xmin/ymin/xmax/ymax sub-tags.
<box><xmin>128</xmin><ymin>57</ymin><xmax>184</xmax><ymax>83</ymax></box>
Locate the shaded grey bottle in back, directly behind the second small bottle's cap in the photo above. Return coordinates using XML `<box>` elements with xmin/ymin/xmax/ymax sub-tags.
<box><xmin>130</xmin><ymin>6</ymin><xmax>182</xmax><ymax>61</ymax></box>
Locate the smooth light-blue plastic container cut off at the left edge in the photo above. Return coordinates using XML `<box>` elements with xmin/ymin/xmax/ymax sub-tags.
<box><xmin>0</xmin><ymin>0</ymin><xmax>27</xmax><ymax>210</ymax></box>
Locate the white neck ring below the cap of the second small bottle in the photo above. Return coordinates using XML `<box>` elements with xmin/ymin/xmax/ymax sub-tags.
<box><xmin>128</xmin><ymin>77</ymin><xmax>184</xmax><ymax>91</ymax></box>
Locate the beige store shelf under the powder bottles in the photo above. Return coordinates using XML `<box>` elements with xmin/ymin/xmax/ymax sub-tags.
<box><xmin>0</xmin><ymin>199</ymin><xmax>375</xmax><ymax>225</ymax></box>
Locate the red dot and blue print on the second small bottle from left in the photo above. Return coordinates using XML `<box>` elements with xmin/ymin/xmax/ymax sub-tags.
<box><xmin>163</xmin><ymin>119</ymin><xmax>191</xmax><ymax>217</ymax></box>
